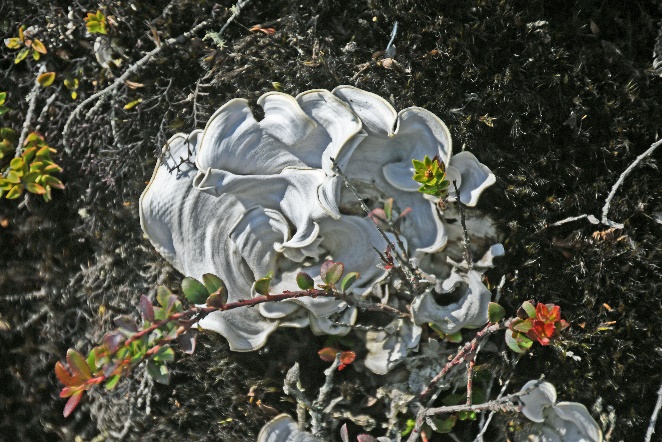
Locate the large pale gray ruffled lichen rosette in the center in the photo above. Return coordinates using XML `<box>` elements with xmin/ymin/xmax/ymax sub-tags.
<box><xmin>140</xmin><ymin>86</ymin><xmax>504</xmax><ymax>373</ymax></box>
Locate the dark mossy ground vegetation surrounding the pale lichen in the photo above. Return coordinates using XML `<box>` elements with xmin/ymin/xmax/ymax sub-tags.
<box><xmin>0</xmin><ymin>0</ymin><xmax>662</xmax><ymax>441</ymax></box>
